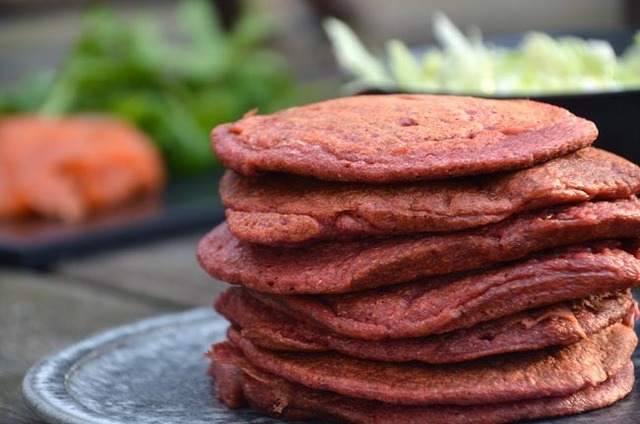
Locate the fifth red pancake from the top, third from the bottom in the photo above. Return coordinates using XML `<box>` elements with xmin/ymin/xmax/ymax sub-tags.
<box><xmin>215</xmin><ymin>287</ymin><xmax>636</xmax><ymax>364</ymax></box>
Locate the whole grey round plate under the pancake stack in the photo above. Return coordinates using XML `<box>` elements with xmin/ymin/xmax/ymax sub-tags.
<box><xmin>23</xmin><ymin>308</ymin><xmax>640</xmax><ymax>424</ymax></box>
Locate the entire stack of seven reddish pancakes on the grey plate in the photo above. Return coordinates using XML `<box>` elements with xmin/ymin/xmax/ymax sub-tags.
<box><xmin>198</xmin><ymin>95</ymin><xmax>640</xmax><ymax>424</ymax></box>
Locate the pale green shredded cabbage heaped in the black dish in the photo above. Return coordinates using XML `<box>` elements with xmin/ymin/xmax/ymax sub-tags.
<box><xmin>324</xmin><ymin>13</ymin><xmax>640</xmax><ymax>96</ymax></box>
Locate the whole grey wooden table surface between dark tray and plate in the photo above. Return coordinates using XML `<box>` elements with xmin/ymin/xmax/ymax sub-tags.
<box><xmin>0</xmin><ymin>230</ymin><xmax>224</xmax><ymax>424</ymax></box>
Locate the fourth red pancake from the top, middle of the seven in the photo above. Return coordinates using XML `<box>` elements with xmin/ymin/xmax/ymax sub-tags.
<box><xmin>247</xmin><ymin>242</ymin><xmax>640</xmax><ymax>340</ymax></box>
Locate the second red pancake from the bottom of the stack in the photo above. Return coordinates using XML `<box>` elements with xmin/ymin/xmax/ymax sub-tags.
<box><xmin>209</xmin><ymin>324</ymin><xmax>637</xmax><ymax>405</ymax></box>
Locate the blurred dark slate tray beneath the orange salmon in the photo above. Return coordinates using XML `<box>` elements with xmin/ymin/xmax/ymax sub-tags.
<box><xmin>0</xmin><ymin>172</ymin><xmax>224</xmax><ymax>268</ymax></box>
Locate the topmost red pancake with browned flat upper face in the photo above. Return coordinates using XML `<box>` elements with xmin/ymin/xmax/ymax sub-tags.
<box><xmin>211</xmin><ymin>94</ymin><xmax>598</xmax><ymax>183</ymax></box>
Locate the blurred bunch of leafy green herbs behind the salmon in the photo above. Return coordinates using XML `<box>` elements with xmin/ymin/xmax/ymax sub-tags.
<box><xmin>0</xmin><ymin>0</ymin><xmax>308</xmax><ymax>174</ymax></box>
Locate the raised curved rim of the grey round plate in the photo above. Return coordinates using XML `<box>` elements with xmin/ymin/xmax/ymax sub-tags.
<box><xmin>21</xmin><ymin>306</ymin><xmax>228</xmax><ymax>424</ymax></box>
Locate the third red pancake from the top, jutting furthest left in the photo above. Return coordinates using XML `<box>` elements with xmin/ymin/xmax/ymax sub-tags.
<box><xmin>197</xmin><ymin>197</ymin><xmax>640</xmax><ymax>294</ymax></box>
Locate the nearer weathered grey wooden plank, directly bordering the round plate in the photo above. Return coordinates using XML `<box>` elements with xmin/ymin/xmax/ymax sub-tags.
<box><xmin>0</xmin><ymin>268</ymin><xmax>178</xmax><ymax>424</ymax></box>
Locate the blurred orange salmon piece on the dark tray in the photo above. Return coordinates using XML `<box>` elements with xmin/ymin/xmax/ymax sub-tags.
<box><xmin>0</xmin><ymin>115</ymin><xmax>166</xmax><ymax>222</ymax></box>
